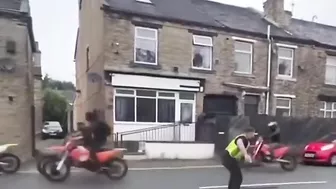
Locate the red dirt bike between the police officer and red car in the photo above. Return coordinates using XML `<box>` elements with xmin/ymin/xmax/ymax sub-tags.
<box><xmin>252</xmin><ymin>137</ymin><xmax>298</xmax><ymax>171</ymax></box>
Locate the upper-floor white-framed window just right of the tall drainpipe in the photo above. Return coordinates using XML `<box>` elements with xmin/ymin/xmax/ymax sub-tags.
<box><xmin>278</xmin><ymin>47</ymin><xmax>294</xmax><ymax>77</ymax></box>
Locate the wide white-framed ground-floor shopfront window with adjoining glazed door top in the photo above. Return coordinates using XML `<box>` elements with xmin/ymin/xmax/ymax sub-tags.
<box><xmin>114</xmin><ymin>88</ymin><xmax>196</xmax><ymax>123</ymax></box>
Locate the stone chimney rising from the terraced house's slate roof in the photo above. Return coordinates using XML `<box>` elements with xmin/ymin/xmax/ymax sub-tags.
<box><xmin>264</xmin><ymin>0</ymin><xmax>292</xmax><ymax>27</ymax></box>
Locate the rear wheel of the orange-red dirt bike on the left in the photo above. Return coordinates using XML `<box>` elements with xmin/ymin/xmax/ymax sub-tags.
<box><xmin>105</xmin><ymin>158</ymin><xmax>128</xmax><ymax>180</ymax></box>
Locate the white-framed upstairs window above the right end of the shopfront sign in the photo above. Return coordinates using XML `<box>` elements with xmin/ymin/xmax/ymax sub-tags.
<box><xmin>192</xmin><ymin>35</ymin><xmax>213</xmax><ymax>70</ymax></box>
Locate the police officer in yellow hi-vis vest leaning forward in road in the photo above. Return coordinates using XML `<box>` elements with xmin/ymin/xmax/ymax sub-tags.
<box><xmin>222</xmin><ymin>127</ymin><xmax>255</xmax><ymax>189</ymax></box>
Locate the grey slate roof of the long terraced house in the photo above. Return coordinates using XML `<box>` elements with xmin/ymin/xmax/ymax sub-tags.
<box><xmin>105</xmin><ymin>0</ymin><xmax>336</xmax><ymax>47</ymax></box>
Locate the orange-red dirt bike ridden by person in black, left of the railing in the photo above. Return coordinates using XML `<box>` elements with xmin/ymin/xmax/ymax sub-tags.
<box><xmin>41</xmin><ymin>137</ymin><xmax>128</xmax><ymax>182</ymax></box>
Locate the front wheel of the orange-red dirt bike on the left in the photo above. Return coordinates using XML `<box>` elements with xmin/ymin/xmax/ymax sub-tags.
<box><xmin>42</xmin><ymin>158</ymin><xmax>71</xmax><ymax>182</ymax></box>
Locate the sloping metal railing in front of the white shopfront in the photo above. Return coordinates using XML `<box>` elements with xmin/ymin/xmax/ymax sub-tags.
<box><xmin>114</xmin><ymin>123</ymin><xmax>195</xmax><ymax>147</ymax></box>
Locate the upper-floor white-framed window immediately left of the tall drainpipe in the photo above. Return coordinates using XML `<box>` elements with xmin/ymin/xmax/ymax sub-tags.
<box><xmin>235</xmin><ymin>41</ymin><xmax>253</xmax><ymax>74</ymax></box>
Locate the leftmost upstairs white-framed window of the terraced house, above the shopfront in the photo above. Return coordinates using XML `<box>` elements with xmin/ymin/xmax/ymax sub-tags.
<box><xmin>134</xmin><ymin>27</ymin><xmax>158</xmax><ymax>65</ymax></box>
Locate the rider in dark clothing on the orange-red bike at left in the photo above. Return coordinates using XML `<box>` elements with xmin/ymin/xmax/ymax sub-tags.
<box><xmin>85</xmin><ymin>112</ymin><xmax>111</xmax><ymax>166</ymax></box>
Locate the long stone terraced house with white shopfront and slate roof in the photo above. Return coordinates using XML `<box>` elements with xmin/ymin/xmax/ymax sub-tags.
<box><xmin>75</xmin><ymin>0</ymin><xmax>336</xmax><ymax>140</ymax></box>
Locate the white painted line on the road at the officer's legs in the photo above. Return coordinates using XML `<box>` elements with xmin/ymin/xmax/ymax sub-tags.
<box><xmin>199</xmin><ymin>181</ymin><xmax>328</xmax><ymax>189</ymax></box>
